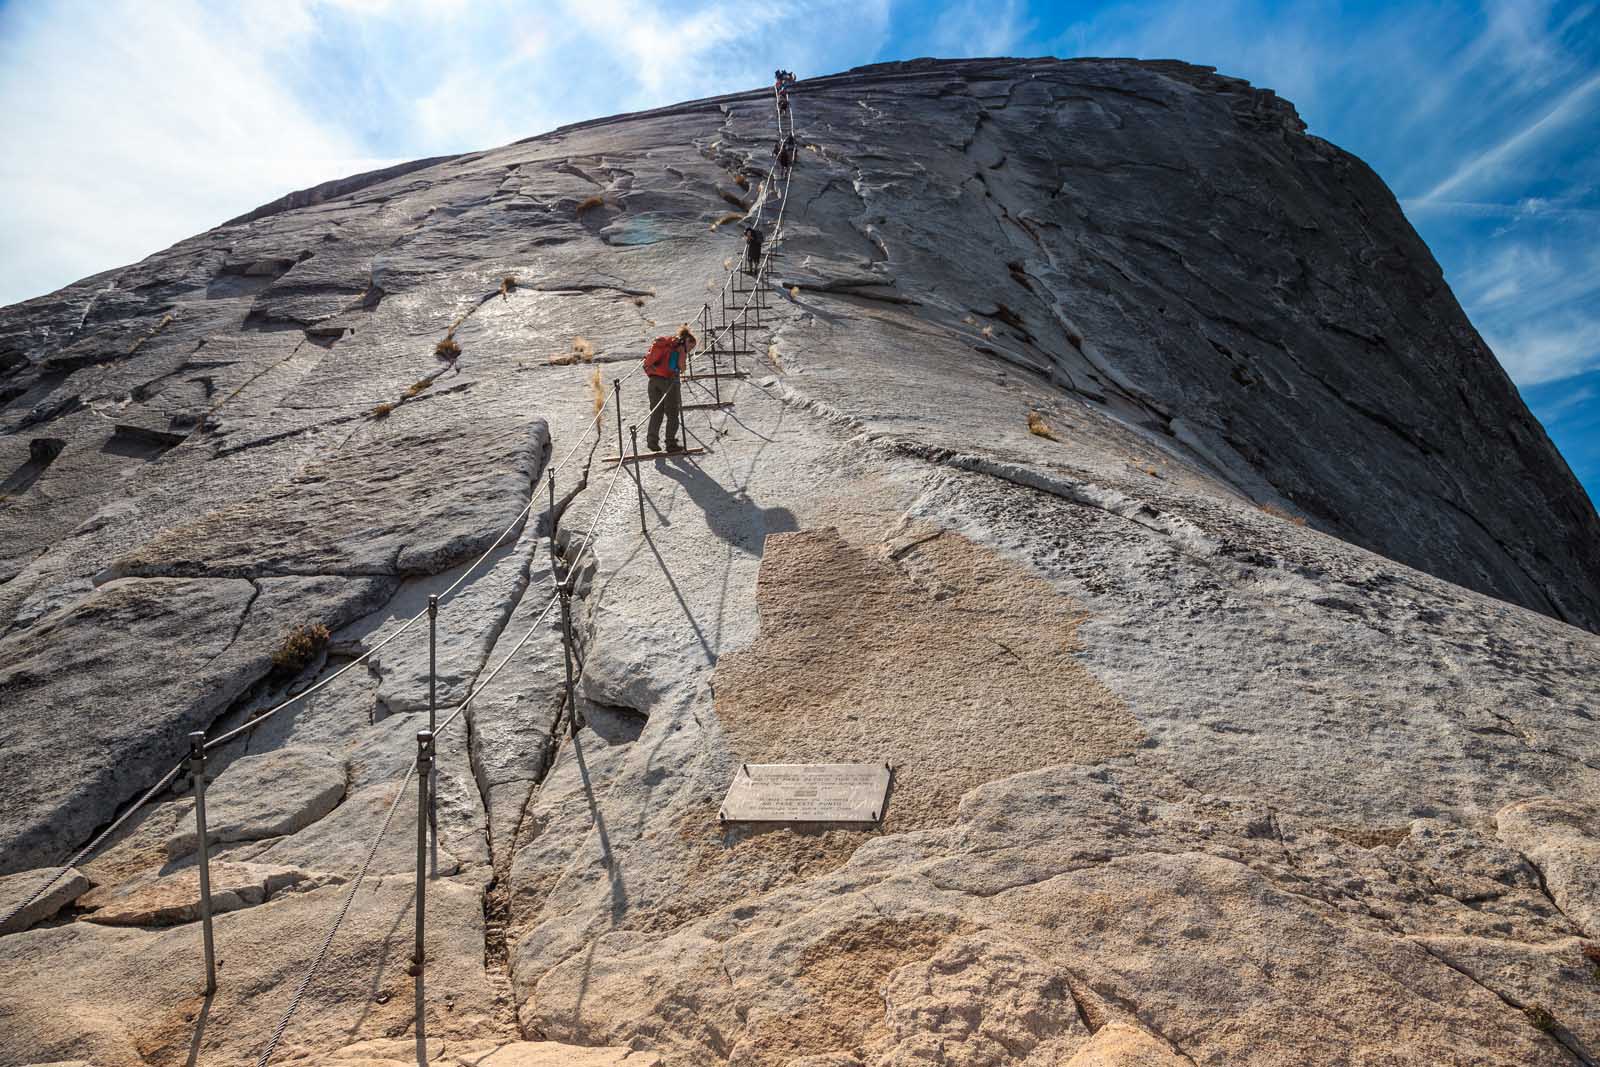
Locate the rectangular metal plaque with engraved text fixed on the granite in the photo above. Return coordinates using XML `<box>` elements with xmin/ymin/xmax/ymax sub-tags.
<box><xmin>718</xmin><ymin>763</ymin><xmax>890</xmax><ymax>822</ymax></box>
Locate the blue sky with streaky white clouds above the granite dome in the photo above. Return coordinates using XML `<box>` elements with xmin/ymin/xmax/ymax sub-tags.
<box><xmin>0</xmin><ymin>0</ymin><xmax>1600</xmax><ymax>499</ymax></box>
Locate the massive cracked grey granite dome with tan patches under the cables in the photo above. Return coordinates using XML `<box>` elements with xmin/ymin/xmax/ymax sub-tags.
<box><xmin>0</xmin><ymin>59</ymin><xmax>1600</xmax><ymax>1067</ymax></box>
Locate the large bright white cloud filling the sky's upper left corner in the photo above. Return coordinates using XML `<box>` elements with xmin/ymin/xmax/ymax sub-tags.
<box><xmin>0</xmin><ymin>0</ymin><xmax>382</xmax><ymax>304</ymax></box>
